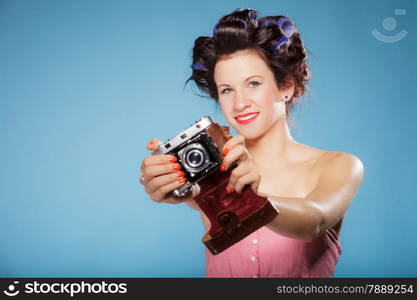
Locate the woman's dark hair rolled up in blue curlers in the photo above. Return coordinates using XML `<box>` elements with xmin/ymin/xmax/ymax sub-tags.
<box><xmin>186</xmin><ymin>9</ymin><xmax>310</xmax><ymax>113</ymax></box>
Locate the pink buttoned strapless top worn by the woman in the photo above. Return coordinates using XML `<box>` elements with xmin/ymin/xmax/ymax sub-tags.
<box><xmin>206</xmin><ymin>227</ymin><xmax>342</xmax><ymax>278</ymax></box>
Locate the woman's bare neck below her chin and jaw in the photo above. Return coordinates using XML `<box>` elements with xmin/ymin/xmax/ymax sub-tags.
<box><xmin>245</xmin><ymin>117</ymin><xmax>295</xmax><ymax>167</ymax></box>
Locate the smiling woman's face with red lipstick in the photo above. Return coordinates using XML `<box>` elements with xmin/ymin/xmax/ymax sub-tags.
<box><xmin>214</xmin><ymin>51</ymin><xmax>285</xmax><ymax>139</ymax></box>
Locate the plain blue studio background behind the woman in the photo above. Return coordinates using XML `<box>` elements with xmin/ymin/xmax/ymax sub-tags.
<box><xmin>0</xmin><ymin>0</ymin><xmax>417</xmax><ymax>277</ymax></box>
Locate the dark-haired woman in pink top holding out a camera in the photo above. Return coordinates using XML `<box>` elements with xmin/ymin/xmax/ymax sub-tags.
<box><xmin>140</xmin><ymin>9</ymin><xmax>364</xmax><ymax>277</ymax></box>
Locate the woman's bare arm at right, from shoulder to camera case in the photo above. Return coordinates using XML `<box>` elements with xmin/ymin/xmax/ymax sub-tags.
<box><xmin>265</xmin><ymin>152</ymin><xmax>364</xmax><ymax>241</ymax></box>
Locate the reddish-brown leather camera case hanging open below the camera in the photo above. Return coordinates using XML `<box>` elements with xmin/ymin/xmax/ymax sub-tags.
<box><xmin>194</xmin><ymin>123</ymin><xmax>278</xmax><ymax>255</ymax></box>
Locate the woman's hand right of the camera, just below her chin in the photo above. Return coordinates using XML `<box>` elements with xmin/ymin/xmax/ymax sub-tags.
<box><xmin>220</xmin><ymin>135</ymin><xmax>261</xmax><ymax>194</ymax></box>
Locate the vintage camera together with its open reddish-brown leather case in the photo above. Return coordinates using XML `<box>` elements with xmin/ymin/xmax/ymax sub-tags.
<box><xmin>154</xmin><ymin>116</ymin><xmax>279</xmax><ymax>254</ymax></box>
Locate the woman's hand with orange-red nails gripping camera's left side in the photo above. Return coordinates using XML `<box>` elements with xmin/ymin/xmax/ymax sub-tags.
<box><xmin>139</xmin><ymin>138</ymin><xmax>199</xmax><ymax>204</ymax></box>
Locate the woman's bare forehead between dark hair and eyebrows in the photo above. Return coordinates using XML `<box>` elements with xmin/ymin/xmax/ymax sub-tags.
<box><xmin>214</xmin><ymin>50</ymin><xmax>272</xmax><ymax>84</ymax></box>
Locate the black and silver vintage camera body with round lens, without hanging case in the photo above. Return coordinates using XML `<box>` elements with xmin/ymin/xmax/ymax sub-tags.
<box><xmin>154</xmin><ymin>116</ymin><xmax>228</xmax><ymax>198</ymax></box>
